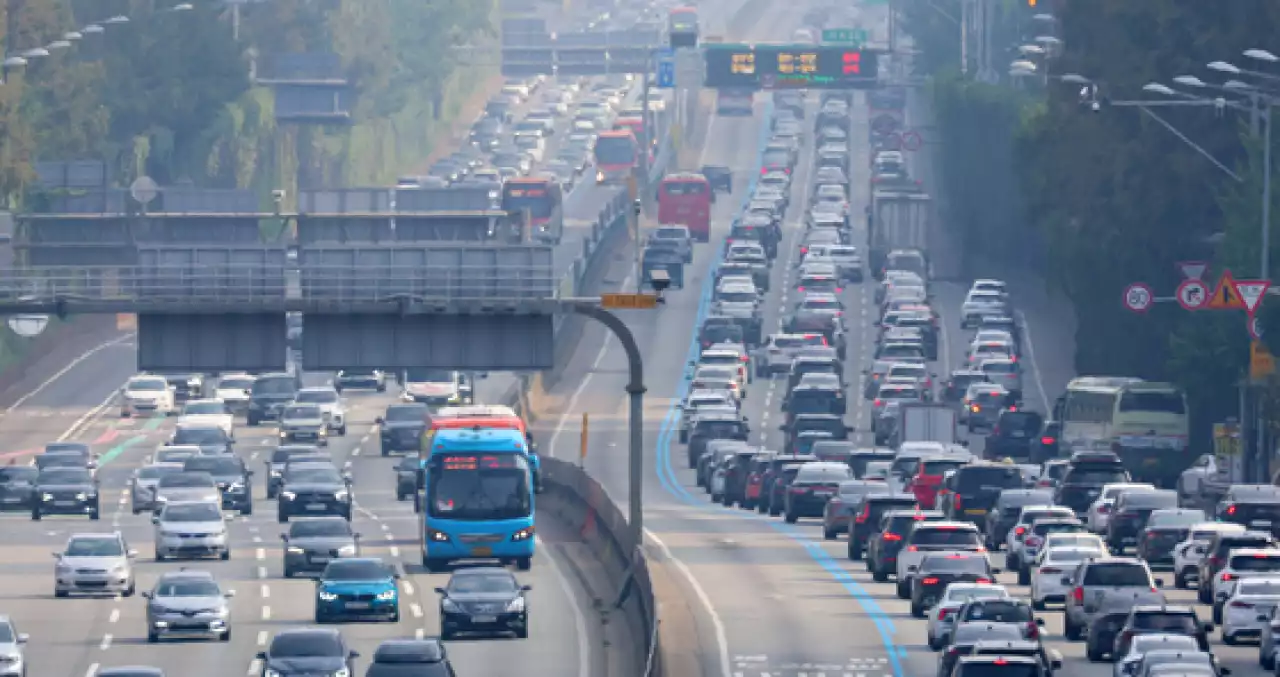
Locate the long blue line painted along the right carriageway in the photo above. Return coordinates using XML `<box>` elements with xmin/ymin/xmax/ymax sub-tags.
<box><xmin>655</xmin><ymin>101</ymin><xmax>906</xmax><ymax>677</ymax></box>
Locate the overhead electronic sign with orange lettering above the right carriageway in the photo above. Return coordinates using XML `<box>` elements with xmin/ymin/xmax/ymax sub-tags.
<box><xmin>705</xmin><ymin>45</ymin><xmax>878</xmax><ymax>90</ymax></box>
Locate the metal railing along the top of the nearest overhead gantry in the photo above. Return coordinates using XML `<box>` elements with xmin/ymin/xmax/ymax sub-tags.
<box><xmin>0</xmin><ymin>264</ymin><xmax>557</xmax><ymax>305</ymax></box>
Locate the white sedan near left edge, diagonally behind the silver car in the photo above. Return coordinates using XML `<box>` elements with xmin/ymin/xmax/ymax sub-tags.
<box><xmin>54</xmin><ymin>531</ymin><xmax>138</xmax><ymax>598</ymax></box>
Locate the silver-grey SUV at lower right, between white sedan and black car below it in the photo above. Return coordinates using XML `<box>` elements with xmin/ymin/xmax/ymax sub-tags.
<box><xmin>1062</xmin><ymin>557</ymin><xmax>1165</xmax><ymax>641</ymax></box>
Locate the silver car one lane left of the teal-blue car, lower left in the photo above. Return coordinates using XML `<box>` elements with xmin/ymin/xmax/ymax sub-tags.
<box><xmin>142</xmin><ymin>569</ymin><xmax>236</xmax><ymax>644</ymax></box>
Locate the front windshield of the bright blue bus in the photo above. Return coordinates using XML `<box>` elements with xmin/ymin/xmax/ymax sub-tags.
<box><xmin>426</xmin><ymin>452</ymin><xmax>532</xmax><ymax>521</ymax></box>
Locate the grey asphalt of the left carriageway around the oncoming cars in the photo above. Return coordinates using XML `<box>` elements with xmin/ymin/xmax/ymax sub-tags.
<box><xmin>0</xmin><ymin>373</ymin><xmax>604</xmax><ymax>677</ymax></box>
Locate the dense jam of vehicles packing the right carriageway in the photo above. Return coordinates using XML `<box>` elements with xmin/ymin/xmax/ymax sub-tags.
<box><xmin>655</xmin><ymin>67</ymin><xmax>1280</xmax><ymax>677</ymax></box>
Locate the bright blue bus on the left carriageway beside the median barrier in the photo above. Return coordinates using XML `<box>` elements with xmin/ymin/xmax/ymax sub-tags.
<box><xmin>420</xmin><ymin>427</ymin><xmax>534</xmax><ymax>571</ymax></box>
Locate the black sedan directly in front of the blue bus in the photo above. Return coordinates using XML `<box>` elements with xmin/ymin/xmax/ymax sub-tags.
<box><xmin>435</xmin><ymin>567</ymin><xmax>532</xmax><ymax>640</ymax></box>
